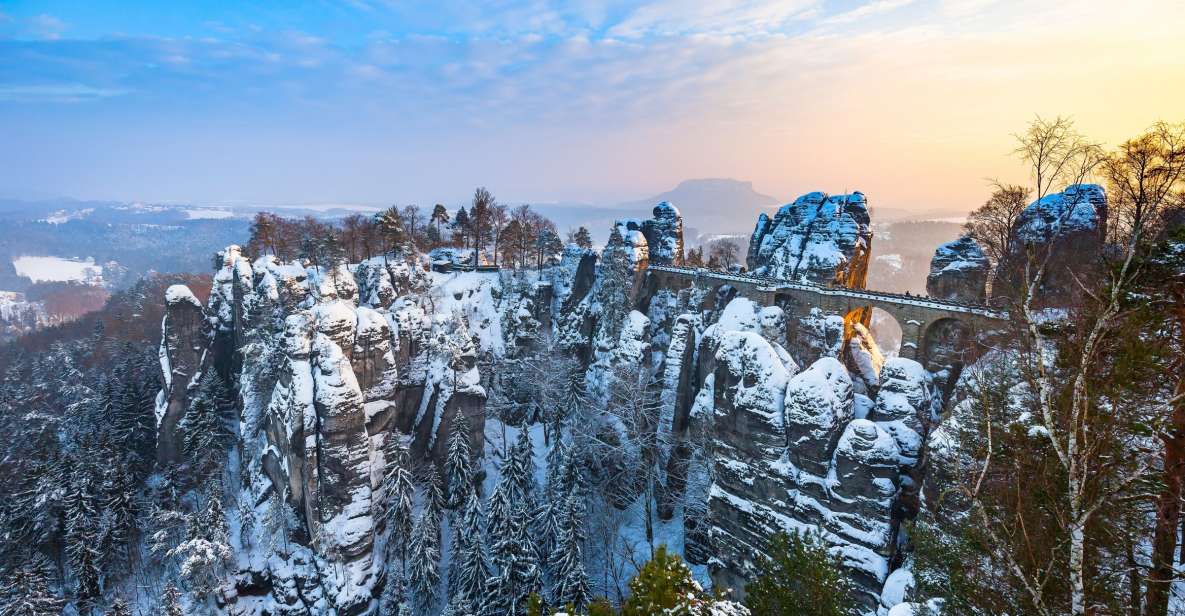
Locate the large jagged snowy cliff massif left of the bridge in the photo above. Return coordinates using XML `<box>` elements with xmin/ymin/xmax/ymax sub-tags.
<box><xmin>158</xmin><ymin>246</ymin><xmax>542</xmax><ymax>615</ymax></box>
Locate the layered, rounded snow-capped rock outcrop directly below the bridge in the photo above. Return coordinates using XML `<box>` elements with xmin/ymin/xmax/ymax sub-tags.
<box><xmin>696</xmin><ymin>299</ymin><xmax>931</xmax><ymax>609</ymax></box>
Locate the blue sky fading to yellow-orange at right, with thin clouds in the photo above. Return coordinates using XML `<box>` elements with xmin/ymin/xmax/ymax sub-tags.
<box><xmin>0</xmin><ymin>0</ymin><xmax>1185</xmax><ymax>211</ymax></box>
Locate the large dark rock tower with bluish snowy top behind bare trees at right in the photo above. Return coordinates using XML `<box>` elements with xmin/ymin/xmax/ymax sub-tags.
<box><xmin>992</xmin><ymin>184</ymin><xmax>1107</xmax><ymax>307</ymax></box>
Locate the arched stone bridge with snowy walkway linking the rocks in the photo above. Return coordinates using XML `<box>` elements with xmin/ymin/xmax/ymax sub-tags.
<box><xmin>649</xmin><ymin>265</ymin><xmax>1008</xmax><ymax>370</ymax></box>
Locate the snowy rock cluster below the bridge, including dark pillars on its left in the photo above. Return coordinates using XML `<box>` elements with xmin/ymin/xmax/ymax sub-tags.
<box><xmin>635</xmin><ymin>286</ymin><xmax>933</xmax><ymax>609</ymax></box>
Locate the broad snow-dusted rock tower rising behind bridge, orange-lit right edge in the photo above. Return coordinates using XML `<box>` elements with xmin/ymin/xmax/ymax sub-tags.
<box><xmin>748</xmin><ymin>192</ymin><xmax>872</xmax><ymax>289</ymax></box>
